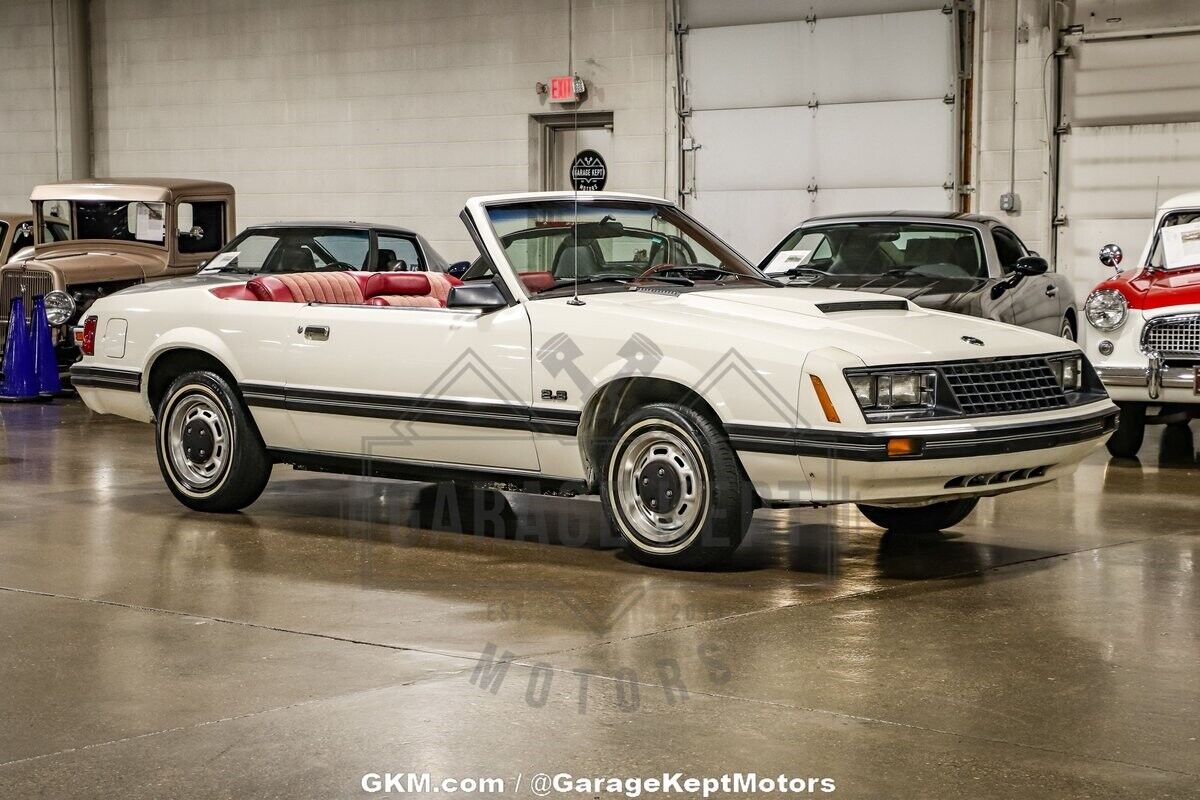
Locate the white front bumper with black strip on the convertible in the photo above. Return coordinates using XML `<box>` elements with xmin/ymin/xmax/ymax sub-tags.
<box><xmin>731</xmin><ymin>401</ymin><xmax>1117</xmax><ymax>505</ymax></box>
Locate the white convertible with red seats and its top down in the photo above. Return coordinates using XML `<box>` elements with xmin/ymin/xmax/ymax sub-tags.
<box><xmin>72</xmin><ymin>193</ymin><xmax>1116</xmax><ymax>567</ymax></box>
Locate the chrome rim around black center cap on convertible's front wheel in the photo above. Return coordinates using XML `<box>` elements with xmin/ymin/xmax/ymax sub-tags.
<box><xmin>608</xmin><ymin>420</ymin><xmax>710</xmax><ymax>555</ymax></box>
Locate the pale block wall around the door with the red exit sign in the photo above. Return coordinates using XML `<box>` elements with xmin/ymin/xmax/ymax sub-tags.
<box><xmin>92</xmin><ymin>0</ymin><xmax>674</xmax><ymax>258</ymax></box>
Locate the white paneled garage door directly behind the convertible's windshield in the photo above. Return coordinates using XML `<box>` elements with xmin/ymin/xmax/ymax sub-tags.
<box><xmin>683</xmin><ymin>0</ymin><xmax>958</xmax><ymax>259</ymax></box>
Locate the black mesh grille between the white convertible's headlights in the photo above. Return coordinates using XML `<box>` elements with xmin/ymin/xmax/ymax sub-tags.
<box><xmin>941</xmin><ymin>357</ymin><xmax>1067</xmax><ymax>415</ymax></box>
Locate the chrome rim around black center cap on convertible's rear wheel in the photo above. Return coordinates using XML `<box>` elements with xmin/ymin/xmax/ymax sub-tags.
<box><xmin>160</xmin><ymin>384</ymin><xmax>234</xmax><ymax>498</ymax></box>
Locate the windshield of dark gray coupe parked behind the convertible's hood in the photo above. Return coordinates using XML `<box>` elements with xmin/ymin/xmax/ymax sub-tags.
<box><xmin>763</xmin><ymin>222</ymin><xmax>988</xmax><ymax>278</ymax></box>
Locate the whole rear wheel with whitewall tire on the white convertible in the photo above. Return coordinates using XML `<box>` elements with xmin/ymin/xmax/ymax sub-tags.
<box><xmin>155</xmin><ymin>371</ymin><xmax>271</xmax><ymax>513</ymax></box>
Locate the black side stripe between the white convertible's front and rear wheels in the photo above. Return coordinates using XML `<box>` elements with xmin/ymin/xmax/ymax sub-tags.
<box><xmin>240</xmin><ymin>384</ymin><xmax>580</xmax><ymax>437</ymax></box>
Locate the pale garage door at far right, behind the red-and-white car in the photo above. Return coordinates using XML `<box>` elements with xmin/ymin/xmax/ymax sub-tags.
<box><xmin>1057</xmin><ymin>32</ymin><xmax>1200</xmax><ymax>321</ymax></box>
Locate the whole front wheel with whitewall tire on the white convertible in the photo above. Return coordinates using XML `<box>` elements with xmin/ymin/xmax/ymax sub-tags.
<box><xmin>600</xmin><ymin>403</ymin><xmax>754</xmax><ymax>570</ymax></box>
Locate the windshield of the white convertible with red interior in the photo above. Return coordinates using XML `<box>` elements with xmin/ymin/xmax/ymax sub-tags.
<box><xmin>463</xmin><ymin>199</ymin><xmax>764</xmax><ymax>296</ymax></box>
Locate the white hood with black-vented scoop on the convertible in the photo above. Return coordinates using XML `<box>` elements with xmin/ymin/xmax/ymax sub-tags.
<box><xmin>586</xmin><ymin>288</ymin><xmax>1075</xmax><ymax>365</ymax></box>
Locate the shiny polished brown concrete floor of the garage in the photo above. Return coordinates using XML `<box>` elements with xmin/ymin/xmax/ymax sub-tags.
<box><xmin>0</xmin><ymin>402</ymin><xmax>1200</xmax><ymax>799</ymax></box>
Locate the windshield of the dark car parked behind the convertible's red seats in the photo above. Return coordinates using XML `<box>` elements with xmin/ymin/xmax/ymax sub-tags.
<box><xmin>205</xmin><ymin>227</ymin><xmax>371</xmax><ymax>272</ymax></box>
